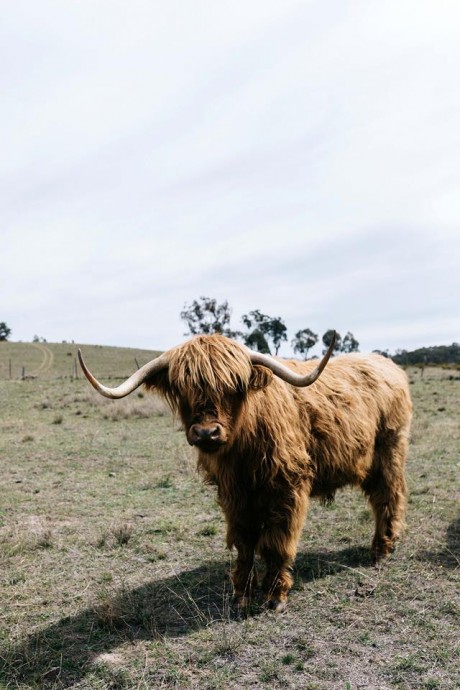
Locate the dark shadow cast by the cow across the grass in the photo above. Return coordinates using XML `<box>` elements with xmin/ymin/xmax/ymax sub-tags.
<box><xmin>0</xmin><ymin>548</ymin><xmax>371</xmax><ymax>688</ymax></box>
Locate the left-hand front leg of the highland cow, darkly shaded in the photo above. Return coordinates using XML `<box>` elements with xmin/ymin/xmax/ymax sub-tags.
<box><xmin>227</xmin><ymin>523</ymin><xmax>259</xmax><ymax>608</ymax></box>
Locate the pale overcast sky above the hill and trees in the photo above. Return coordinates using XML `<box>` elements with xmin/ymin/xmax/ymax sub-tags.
<box><xmin>0</xmin><ymin>0</ymin><xmax>460</xmax><ymax>356</ymax></box>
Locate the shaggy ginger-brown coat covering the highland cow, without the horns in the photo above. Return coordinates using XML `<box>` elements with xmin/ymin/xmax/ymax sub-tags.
<box><xmin>146</xmin><ymin>335</ymin><xmax>412</xmax><ymax>610</ymax></box>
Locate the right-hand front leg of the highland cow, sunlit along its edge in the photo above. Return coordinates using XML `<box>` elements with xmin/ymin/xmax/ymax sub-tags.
<box><xmin>257</xmin><ymin>494</ymin><xmax>308</xmax><ymax>612</ymax></box>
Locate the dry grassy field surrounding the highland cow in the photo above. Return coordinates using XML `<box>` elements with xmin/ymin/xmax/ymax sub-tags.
<box><xmin>0</xmin><ymin>343</ymin><xmax>460</xmax><ymax>690</ymax></box>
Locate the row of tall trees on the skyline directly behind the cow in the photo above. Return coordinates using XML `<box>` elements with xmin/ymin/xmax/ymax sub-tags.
<box><xmin>180</xmin><ymin>297</ymin><xmax>359</xmax><ymax>359</ymax></box>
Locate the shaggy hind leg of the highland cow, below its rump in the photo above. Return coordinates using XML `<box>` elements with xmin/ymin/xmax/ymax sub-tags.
<box><xmin>363</xmin><ymin>430</ymin><xmax>408</xmax><ymax>563</ymax></box>
